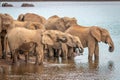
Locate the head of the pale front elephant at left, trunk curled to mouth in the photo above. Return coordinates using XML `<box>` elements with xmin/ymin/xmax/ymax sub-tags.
<box><xmin>42</xmin><ymin>30</ymin><xmax>67</xmax><ymax>46</ymax></box>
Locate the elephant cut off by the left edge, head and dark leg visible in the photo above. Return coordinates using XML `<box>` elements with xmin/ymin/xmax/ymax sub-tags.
<box><xmin>0</xmin><ymin>14</ymin><xmax>13</xmax><ymax>57</ymax></box>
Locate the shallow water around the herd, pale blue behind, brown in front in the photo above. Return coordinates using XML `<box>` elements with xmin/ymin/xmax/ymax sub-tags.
<box><xmin>0</xmin><ymin>2</ymin><xmax>120</xmax><ymax>80</ymax></box>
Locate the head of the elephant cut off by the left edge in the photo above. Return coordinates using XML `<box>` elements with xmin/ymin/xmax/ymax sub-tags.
<box><xmin>0</xmin><ymin>14</ymin><xmax>13</xmax><ymax>32</ymax></box>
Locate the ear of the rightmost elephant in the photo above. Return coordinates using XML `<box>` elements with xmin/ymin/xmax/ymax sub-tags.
<box><xmin>90</xmin><ymin>26</ymin><xmax>101</xmax><ymax>42</ymax></box>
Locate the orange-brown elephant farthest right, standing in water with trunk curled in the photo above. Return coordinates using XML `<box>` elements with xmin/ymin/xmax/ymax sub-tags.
<box><xmin>65</xmin><ymin>26</ymin><xmax>114</xmax><ymax>60</ymax></box>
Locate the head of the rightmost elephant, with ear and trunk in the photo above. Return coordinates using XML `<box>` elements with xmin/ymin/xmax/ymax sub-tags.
<box><xmin>90</xmin><ymin>26</ymin><xmax>114</xmax><ymax>52</ymax></box>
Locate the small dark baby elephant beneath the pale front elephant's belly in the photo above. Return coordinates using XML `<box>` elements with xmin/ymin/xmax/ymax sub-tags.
<box><xmin>16</xmin><ymin>42</ymin><xmax>37</xmax><ymax>63</ymax></box>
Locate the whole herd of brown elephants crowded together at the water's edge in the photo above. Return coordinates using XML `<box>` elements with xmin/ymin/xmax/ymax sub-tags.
<box><xmin>0</xmin><ymin>13</ymin><xmax>114</xmax><ymax>64</ymax></box>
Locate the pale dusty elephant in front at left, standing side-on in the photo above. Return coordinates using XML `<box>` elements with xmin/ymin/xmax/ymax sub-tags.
<box><xmin>4</xmin><ymin>27</ymin><xmax>67</xmax><ymax>64</ymax></box>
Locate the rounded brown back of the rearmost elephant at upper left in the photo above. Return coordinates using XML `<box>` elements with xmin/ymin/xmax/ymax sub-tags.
<box><xmin>17</xmin><ymin>13</ymin><xmax>46</xmax><ymax>24</ymax></box>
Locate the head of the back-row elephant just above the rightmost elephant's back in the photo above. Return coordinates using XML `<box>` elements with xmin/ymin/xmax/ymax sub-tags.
<box><xmin>55</xmin><ymin>17</ymin><xmax>77</xmax><ymax>32</ymax></box>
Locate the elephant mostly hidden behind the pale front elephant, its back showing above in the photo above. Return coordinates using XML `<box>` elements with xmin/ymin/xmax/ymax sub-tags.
<box><xmin>1</xmin><ymin>20</ymin><xmax>45</xmax><ymax>59</ymax></box>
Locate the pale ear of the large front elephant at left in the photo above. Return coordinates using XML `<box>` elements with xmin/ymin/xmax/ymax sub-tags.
<box><xmin>42</xmin><ymin>34</ymin><xmax>54</xmax><ymax>46</ymax></box>
